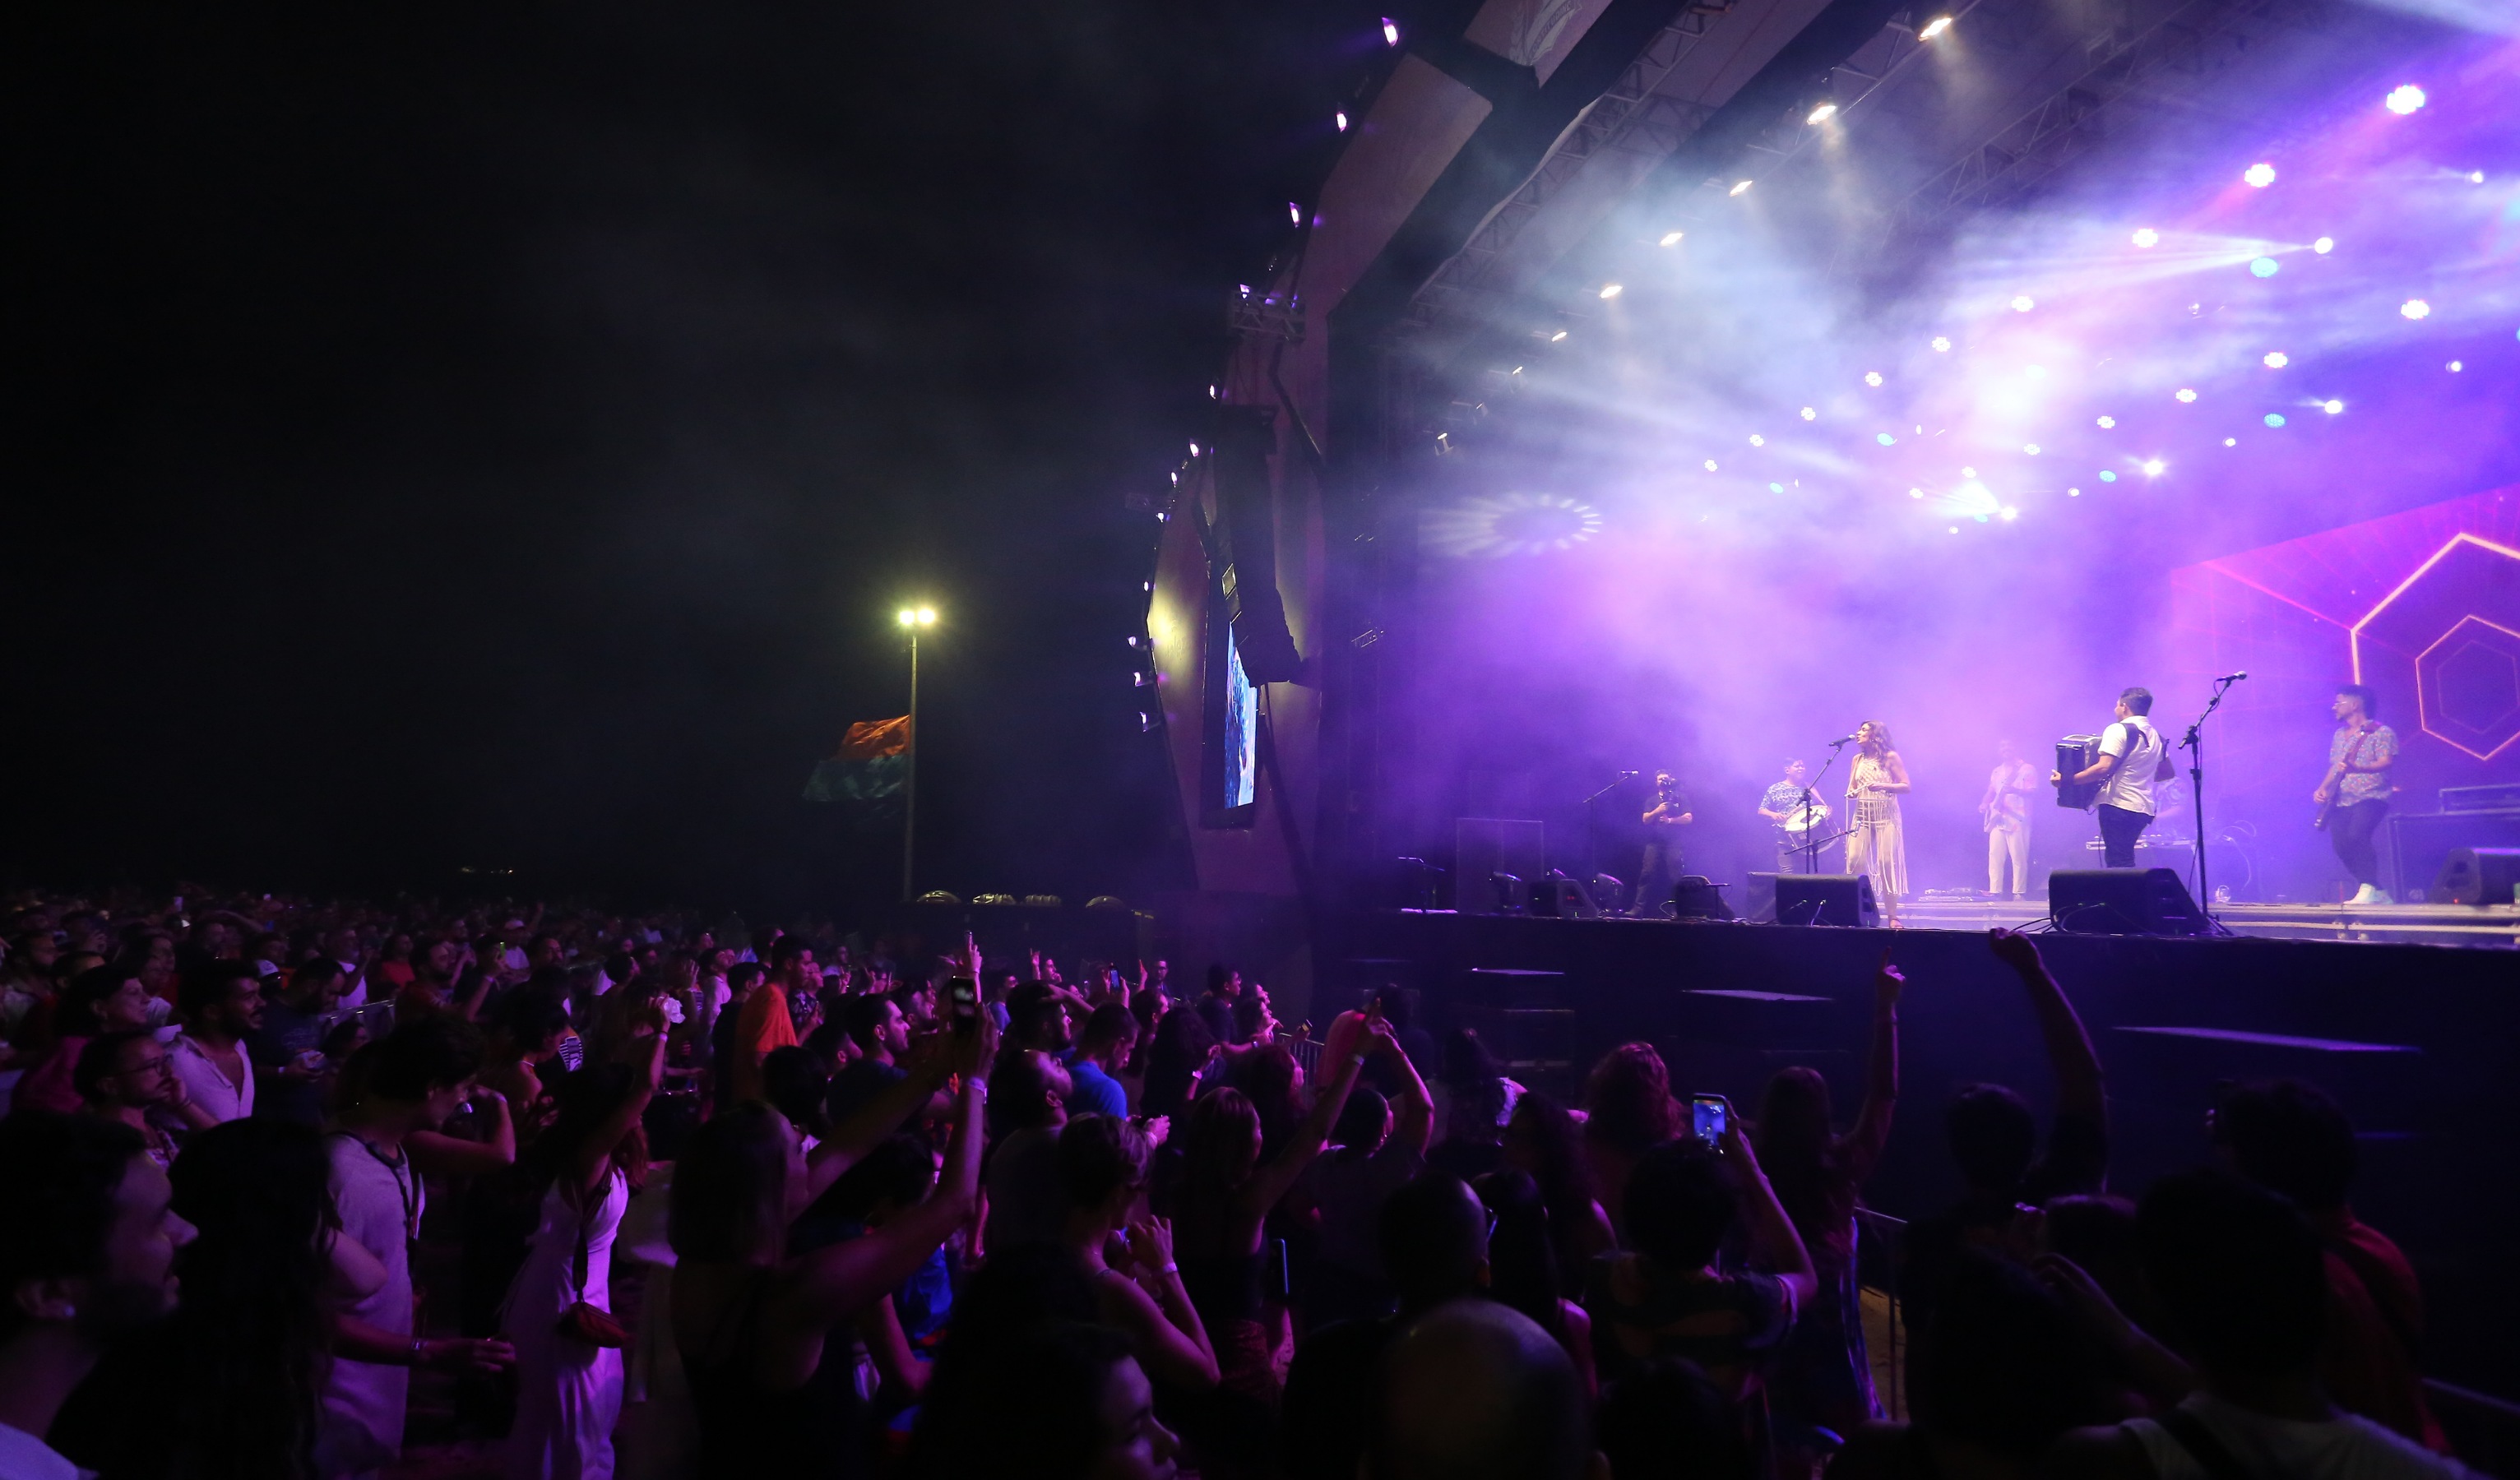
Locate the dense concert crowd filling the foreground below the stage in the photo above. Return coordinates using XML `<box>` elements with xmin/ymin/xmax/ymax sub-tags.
<box><xmin>0</xmin><ymin>893</ymin><xmax>2470</xmax><ymax>1480</ymax></box>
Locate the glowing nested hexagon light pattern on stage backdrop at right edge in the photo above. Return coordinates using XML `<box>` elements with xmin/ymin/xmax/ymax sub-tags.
<box><xmin>2351</xmin><ymin>532</ymin><xmax>2520</xmax><ymax>761</ymax></box>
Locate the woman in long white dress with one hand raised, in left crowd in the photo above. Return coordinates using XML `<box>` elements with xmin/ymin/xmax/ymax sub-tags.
<box><xmin>499</xmin><ymin>1036</ymin><xmax>665</xmax><ymax>1480</ymax></box>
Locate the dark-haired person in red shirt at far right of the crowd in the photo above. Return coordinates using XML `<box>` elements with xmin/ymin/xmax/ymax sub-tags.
<box><xmin>2210</xmin><ymin>1079</ymin><xmax>2449</xmax><ymax>1455</ymax></box>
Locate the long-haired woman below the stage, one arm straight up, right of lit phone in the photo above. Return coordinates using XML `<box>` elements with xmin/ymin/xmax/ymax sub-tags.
<box><xmin>1751</xmin><ymin>950</ymin><xmax>1905</xmax><ymax>1445</ymax></box>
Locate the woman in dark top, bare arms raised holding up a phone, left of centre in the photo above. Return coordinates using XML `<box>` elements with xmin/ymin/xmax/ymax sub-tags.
<box><xmin>665</xmin><ymin>1019</ymin><xmax>998</xmax><ymax>1480</ymax></box>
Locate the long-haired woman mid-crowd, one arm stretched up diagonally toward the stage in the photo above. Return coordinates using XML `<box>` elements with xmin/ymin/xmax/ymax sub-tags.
<box><xmin>1172</xmin><ymin>1014</ymin><xmax>1391</xmax><ymax>1404</ymax></box>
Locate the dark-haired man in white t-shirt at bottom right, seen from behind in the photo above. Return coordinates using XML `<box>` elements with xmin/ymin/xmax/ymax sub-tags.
<box><xmin>2049</xmin><ymin>1172</ymin><xmax>2475</xmax><ymax>1480</ymax></box>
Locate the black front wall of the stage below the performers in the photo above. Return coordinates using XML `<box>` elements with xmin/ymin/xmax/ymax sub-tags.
<box><xmin>1315</xmin><ymin>913</ymin><xmax>2520</xmax><ymax>1394</ymax></box>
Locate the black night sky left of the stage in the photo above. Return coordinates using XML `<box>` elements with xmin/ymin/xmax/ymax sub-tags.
<box><xmin>0</xmin><ymin>0</ymin><xmax>1378</xmax><ymax>913</ymax></box>
